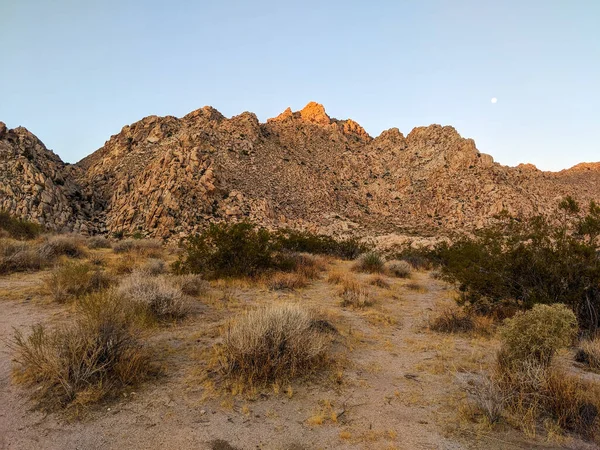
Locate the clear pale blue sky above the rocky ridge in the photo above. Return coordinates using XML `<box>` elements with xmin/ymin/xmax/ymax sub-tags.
<box><xmin>0</xmin><ymin>0</ymin><xmax>600</xmax><ymax>170</ymax></box>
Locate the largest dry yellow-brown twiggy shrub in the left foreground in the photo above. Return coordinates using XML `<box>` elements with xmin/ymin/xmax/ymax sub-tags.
<box><xmin>11</xmin><ymin>310</ymin><xmax>151</xmax><ymax>410</ymax></box>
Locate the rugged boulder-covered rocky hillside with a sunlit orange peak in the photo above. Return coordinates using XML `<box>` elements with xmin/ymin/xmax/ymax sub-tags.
<box><xmin>0</xmin><ymin>103</ymin><xmax>600</xmax><ymax>241</ymax></box>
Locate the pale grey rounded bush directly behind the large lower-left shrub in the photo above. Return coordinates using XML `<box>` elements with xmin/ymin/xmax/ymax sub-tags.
<box><xmin>117</xmin><ymin>272</ymin><xmax>189</xmax><ymax>320</ymax></box>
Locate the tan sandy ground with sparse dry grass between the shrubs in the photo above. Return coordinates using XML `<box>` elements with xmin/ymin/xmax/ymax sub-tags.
<box><xmin>0</xmin><ymin>262</ymin><xmax>592</xmax><ymax>450</ymax></box>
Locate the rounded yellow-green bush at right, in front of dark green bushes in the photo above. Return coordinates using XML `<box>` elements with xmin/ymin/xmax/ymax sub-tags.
<box><xmin>499</xmin><ymin>304</ymin><xmax>577</xmax><ymax>367</ymax></box>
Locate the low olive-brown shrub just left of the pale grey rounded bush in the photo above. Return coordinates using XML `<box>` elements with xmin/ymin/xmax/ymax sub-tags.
<box><xmin>44</xmin><ymin>262</ymin><xmax>112</xmax><ymax>302</ymax></box>
